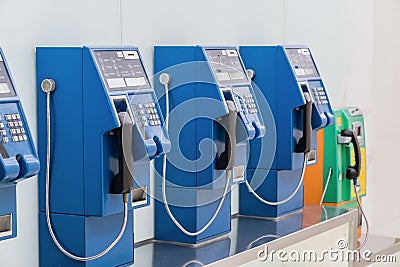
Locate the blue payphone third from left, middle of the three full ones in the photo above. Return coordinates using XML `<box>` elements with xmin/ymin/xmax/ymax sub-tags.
<box><xmin>154</xmin><ymin>46</ymin><xmax>265</xmax><ymax>244</ymax></box>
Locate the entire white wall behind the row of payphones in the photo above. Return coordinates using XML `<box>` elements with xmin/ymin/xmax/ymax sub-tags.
<box><xmin>0</xmin><ymin>0</ymin><xmax>390</xmax><ymax>267</ymax></box>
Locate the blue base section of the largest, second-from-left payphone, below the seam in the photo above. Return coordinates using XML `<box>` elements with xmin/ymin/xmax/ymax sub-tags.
<box><xmin>39</xmin><ymin>211</ymin><xmax>133</xmax><ymax>267</ymax></box>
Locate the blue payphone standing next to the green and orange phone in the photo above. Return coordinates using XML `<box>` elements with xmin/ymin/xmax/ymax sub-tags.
<box><xmin>239</xmin><ymin>46</ymin><xmax>334</xmax><ymax>218</ymax></box>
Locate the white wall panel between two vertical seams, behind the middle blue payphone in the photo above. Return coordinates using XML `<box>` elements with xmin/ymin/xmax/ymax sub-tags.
<box><xmin>122</xmin><ymin>0</ymin><xmax>285</xmax><ymax>243</ymax></box>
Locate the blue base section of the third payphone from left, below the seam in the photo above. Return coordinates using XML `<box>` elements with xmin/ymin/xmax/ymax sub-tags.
<box><xmin>155</xmin><ymin>187</ymin><xmax>231</xmax><ymax>244</ymax></box>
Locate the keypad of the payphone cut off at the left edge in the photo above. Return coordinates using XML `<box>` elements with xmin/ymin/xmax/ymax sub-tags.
<box><xmin>0</xmin><ymin>113</ymin><xmax>28</xmax><ymax>144</ymax></box>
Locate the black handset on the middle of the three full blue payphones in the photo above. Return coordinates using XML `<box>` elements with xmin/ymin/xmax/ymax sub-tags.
<box><xmin>215</xmin><ymin>100</ymin><xmax>237</xmax><ymax>170</ymax></box>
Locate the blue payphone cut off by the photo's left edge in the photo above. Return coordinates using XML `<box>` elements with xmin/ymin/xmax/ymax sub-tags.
<box><xmin>0</xmin><ymin>48</ymin><xmax>40</xmax><ymax>243</ymax></box>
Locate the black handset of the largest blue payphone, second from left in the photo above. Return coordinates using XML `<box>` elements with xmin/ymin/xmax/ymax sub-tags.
<box><xmin>110</xmin><ymin>112</ymin><xmax>133</xmax><ymax>194</ymax></box>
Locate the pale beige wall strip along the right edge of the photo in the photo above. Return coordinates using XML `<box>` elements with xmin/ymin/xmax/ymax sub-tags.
<box><xmin>368</xmin><ymin>0</ymin><xmax>400</xmax><ymax>239</ymax></box>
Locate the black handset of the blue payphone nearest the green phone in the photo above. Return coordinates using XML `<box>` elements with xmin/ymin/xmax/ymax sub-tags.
<box><xmin>295</xmin><ymin>92</ymin><xmax>312</xmax><ymax>153</ymax></box>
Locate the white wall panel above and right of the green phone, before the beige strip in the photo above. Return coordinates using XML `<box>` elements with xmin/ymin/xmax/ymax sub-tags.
<box><xmin>285</xmin><ymin>0</ymin><xmax>376</xmax><ymax>232</ymax></box>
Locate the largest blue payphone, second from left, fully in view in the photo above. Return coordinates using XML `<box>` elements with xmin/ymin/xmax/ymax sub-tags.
<box><xmin>36</xmin><ymin>47</ymin><xmax>170</xmax><ymax>267</ymax></box>
